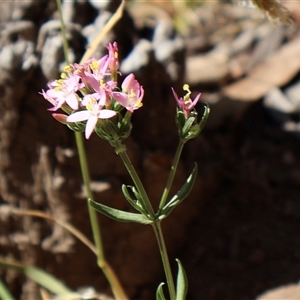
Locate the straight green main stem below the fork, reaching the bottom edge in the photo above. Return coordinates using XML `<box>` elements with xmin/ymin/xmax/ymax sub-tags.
<box><xmin>152</xmin><ymin>221</ymin><xmax>176</xmax><ymax>300</ymax></box>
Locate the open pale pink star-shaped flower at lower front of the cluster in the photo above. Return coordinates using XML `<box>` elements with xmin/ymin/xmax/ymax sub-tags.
<box><xmin>66</xmin><ymin>92</ymin><xmax>116</xmax><ymax>139</ymax></box>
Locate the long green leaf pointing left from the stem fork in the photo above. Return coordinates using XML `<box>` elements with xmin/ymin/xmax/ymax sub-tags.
<box><xmin>89</xmin><ymin>199</ymin><xmax>153</xmax><ymax>225</ymax></box>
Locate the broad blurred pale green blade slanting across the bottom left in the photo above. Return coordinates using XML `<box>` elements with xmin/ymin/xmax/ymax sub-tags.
<box><xmin>0</xmin><ymin>260</ymin><xmax>72</xmax><ymax>295</ymax></box>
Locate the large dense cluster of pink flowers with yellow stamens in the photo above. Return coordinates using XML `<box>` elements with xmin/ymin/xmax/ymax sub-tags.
<box><xmin>41</xmin><ymin>42</ymin><xmax>144</xmax><ymax>139</ymax></box>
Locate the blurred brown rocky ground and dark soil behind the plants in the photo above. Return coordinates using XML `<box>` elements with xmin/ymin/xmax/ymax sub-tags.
<box><xmin>0</xmin><ymin>1</ymin><xmax>300</xmax><ymax>300</ymax></box>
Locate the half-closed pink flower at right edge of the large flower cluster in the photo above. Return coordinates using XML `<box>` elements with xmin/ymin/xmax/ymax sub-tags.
<box><xmin>112</xmin><ymin>74</ymin><xmax>144</xmax><ymax>112</ymax></box>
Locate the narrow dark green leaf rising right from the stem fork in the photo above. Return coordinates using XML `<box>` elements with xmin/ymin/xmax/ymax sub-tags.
<box><xmin>158</xmin><ymin>164</ymin><xmax>198</xmax><ymax>220</ymax></box>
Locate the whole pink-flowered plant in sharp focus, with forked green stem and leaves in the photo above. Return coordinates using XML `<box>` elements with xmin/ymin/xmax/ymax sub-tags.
<box><xmin>41</xmin><ymin>42</ymin><xmax>209</xmax><ymax>300</ymax></box>
